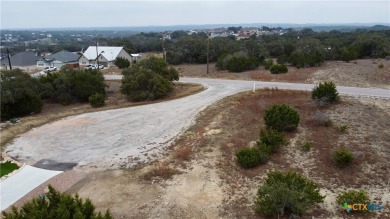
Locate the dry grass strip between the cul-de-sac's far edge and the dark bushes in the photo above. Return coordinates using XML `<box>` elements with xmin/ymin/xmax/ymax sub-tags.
<box><xmin>0</xmin><ymin>81</ymin><xmax>204</xmax><ymax>155</ymax></box>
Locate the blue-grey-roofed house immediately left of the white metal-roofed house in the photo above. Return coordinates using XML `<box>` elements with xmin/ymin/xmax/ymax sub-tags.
<box><xmin>37</xmin><ymin>50</ymin><xmax>80</xmax><ymax>69</ymax></box>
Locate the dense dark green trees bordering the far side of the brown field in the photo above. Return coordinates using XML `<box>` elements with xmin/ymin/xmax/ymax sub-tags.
<box><xmin>162</xmin><ymin>29</ymin><xmax>390</xmax><ymax>67</ymax></box>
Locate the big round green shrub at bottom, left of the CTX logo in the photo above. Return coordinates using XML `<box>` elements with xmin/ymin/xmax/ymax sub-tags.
<box><xmin>255</xmin><ymin>171</ymin><xmax>325</xmax><ymax>217</ymax></box>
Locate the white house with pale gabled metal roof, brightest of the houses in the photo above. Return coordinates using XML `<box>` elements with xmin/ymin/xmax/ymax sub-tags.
<box><xmin>79</xmin><ymin>46</ymin><xmax>132</xmax><ymax>67</ymax></box>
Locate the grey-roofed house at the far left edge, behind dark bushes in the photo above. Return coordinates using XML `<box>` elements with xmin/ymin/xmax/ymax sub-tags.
<box><xmin>0</xmin><ymin>52</ymin><xmax>42</xmax><ymax>71</ymax></box>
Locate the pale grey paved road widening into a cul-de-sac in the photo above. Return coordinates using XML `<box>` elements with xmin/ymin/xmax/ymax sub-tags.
<box><xmin>6</xmin><ymin>78</ymin><xmax>390</xmax><ymax>170</ymax></box>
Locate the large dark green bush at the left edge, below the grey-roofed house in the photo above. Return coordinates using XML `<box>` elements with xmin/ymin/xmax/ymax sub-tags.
<box><xmin>0</xmin><ymin>69</ymin><xmax>43</xmax><ymax>120</ymax></box>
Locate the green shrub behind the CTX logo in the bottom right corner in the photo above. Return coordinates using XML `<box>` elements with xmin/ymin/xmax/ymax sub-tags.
<box><xmin>336</xmin><ymin>190</ymin><xmax>370</xmax><ymax>213</ymax></box>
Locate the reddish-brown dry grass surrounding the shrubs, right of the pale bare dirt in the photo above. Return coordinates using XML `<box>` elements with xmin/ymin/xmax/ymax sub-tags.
<box><xmin>169</xmin><ymin>88</ymin><xmax>390</xmax><ymax>218</ymax></box>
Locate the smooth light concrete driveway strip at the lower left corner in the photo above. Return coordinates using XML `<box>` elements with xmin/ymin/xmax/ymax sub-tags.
<box><xmin>0</xmin><ymin>165</ymin><xmax>62</xmax><ymax>211</ymax></box>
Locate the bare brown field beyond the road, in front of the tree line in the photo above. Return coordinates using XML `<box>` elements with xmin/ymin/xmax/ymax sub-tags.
<box><xmin>174</xmin><ymin>59</ymin><xmax>390</xmax><ymax>89</ymax></box>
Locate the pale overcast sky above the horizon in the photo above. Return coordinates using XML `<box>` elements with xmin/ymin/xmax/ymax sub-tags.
<box><xmin>0</xmin><ymin>0</ymin><xmax>390</xmax><ymax>29</ymax></box>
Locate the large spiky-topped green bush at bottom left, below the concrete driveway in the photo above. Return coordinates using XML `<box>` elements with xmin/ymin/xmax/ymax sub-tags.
<box><xmin>2</xmin><ymin>186</ymin><xmax>113</xmax><ymax>219</ymax></box>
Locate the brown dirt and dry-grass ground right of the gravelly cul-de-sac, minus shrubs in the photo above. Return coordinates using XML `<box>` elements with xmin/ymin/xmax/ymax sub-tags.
<box><xmin>70</xmin><ymin>89</ymin><xmax>390</xmax><ymax>218</ymax></box>
